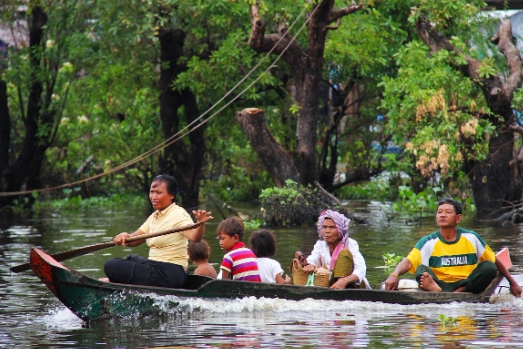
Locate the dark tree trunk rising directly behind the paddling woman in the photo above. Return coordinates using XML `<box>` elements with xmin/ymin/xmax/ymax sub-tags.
<box><xmin>158</xmin><ymin>28</ymin><xmax>205</xmax><ymax>209</ymax></box>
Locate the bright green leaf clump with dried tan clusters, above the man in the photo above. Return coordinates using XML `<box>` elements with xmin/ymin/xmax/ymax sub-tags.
<box><xmin>382</xmin><ymin>42</ymin><xmax>495</xmax><ymax>184</ymax></box>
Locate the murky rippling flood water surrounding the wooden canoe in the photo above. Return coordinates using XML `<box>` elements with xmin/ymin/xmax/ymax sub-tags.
<box><xmin>0</xmin><ymin>202</ymin><xmax>523</xmax><ymax>348</ymax></box>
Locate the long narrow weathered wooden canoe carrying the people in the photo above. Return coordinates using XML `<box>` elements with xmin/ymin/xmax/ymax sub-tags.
<box><xmin>30</xmin><ymin>248</ymin><xmax>510</xmax><ymax>320</ymax></box>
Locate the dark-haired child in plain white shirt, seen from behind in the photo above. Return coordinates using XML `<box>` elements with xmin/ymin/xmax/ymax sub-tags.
<box><xmin>249</xmin><ymin>230</ymin><xmax>291</xmax><ymax>284</ymax></box>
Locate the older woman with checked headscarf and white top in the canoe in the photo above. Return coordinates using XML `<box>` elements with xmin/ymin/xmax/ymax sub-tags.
<box><xmin>303</xmin><ymin>210</ymin><xmax>370</xmax><ymax>289</ymax></box>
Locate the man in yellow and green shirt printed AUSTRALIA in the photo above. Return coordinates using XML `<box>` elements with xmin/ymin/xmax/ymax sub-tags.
<box><xmin>385</xmin><ymin>199</ymin><xmax>522</xmax><ymax>297</ymax></box>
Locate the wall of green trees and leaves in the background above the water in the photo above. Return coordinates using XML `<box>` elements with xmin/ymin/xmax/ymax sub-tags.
<box><xmin>0</xmin><ymin>0</ymin><xmax>523</xmax><ymax>223</ymax></box>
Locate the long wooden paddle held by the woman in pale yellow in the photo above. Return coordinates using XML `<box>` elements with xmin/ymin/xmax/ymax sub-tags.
<box><xmin>10</xmin><ymin>222</ymin><xmax>203</xmax><ymax>273</ymax></box>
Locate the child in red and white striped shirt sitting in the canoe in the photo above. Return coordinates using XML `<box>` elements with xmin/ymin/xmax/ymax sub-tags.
<box><xmin>216</xmin><ymin>217</ymin><xmax>261</xmax><ymax>282</ymax></box>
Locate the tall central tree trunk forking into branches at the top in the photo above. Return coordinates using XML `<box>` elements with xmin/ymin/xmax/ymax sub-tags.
<box><xmin>249</xmin><ymin>0</ymin><xmax>363</xmax><ymax>185</ymax></box>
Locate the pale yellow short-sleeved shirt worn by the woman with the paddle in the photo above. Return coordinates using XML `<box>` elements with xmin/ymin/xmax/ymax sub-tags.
<box><xmin>140</xmin><ymin>203</ymin><xmax>194</xmax><ymax>268</ymax></box>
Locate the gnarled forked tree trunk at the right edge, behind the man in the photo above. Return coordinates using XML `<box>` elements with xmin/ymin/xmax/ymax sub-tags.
<box><xmin>417</xmin><ymin>17</ymin><xmax>523</xmax><ymax>219</ymax></box>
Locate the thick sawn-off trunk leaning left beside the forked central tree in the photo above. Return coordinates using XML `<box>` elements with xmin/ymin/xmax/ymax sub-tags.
<box><xmin>236</xmin><ymin>108</ymin><xmax>299</xmax><ymax>187</ymax></box>
